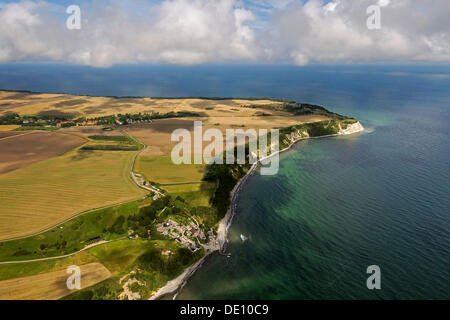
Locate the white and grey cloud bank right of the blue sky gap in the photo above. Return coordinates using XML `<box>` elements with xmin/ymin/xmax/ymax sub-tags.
<box><xmin>270</xmin><ymin>0</ymin><xmax>450</xmax><ymax>65</ymax></box>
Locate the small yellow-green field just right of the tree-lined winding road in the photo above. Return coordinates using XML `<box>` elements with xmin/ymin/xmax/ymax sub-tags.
<box><xmin>135</xmin><ymin>156</ymin><xmax>206</xmax><ymax>184</ymax></box>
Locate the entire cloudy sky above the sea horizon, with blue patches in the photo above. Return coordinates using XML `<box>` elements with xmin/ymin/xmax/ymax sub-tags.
<box><xmin>0</xmin><ymin>0</ymin><xmax>450</xmax><ymax>68</ymax></box>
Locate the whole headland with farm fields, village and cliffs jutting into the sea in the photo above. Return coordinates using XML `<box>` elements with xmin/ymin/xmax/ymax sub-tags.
<box><xmin>0</xmin><ymin>91</ymin><xmax>363</xmax><ymax>299</ymax></box>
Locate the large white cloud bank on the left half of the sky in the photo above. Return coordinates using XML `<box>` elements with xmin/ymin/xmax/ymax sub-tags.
<box><xmin>0</xmin><ymin>0</ymin><xmax>255</xmax><ymax>67</ymax></box>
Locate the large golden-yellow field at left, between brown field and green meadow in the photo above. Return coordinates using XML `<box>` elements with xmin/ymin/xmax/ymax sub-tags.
<box><xmin>0</xmin><ymin>150</ymin><xmax>146</xmax><ymax>240</ymax></box>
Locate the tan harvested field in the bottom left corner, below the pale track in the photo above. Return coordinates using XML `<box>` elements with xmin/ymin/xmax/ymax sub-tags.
<box><xmin>0</xmin><ymin>263</ymin><xmax>111</xmax><ymax>300</ymax></box>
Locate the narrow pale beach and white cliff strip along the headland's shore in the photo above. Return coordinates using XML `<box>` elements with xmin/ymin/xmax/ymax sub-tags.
<box><xmin>149</xmin><ymin>121</ymin><xmax>365</xmax><ymax>300</ymax></box>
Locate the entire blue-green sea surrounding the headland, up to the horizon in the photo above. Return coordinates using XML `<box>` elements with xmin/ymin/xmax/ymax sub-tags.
<box><xmin>0</xmin><ymin>65</ymin><xmax>450</xmax><ymax>299</ymax></box>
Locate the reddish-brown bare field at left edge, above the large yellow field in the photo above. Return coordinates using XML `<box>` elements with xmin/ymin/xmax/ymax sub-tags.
<box><xmin>0</xmin><ymin>132</ymin><xmax>85</xmax><ymax>175</ymax></box>
